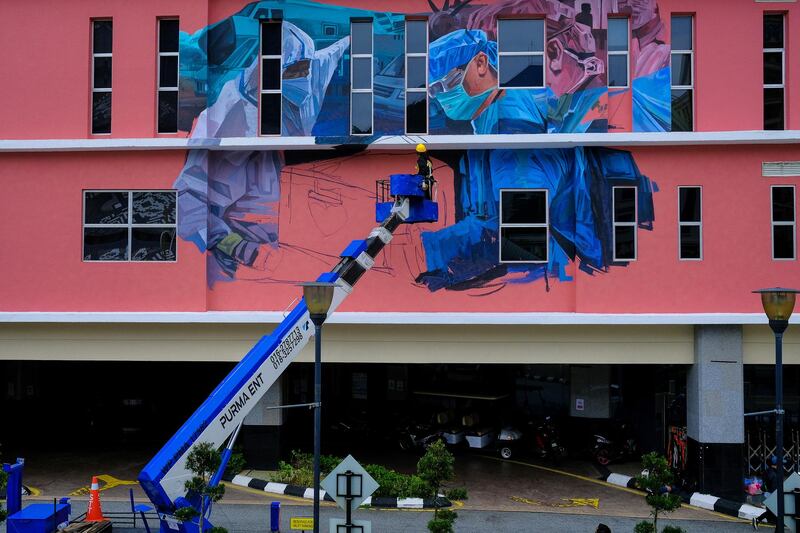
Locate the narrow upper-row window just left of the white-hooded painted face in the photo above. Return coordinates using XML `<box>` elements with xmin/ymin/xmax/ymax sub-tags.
<box><xmin>259</xmin><ymin>21</ymin><xmax>282</xmax><ymax>135</ymax></box>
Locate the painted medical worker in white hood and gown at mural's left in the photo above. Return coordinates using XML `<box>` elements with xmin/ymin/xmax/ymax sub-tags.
<box><xmin>174</xmin><ymin>21</ymin><xmax>349</xmax><ymax>283</ymax></box>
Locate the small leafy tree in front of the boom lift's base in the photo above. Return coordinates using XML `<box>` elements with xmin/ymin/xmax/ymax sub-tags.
<box><xmin>175</xmin><ymin>442</ymin><xmax>227</xmax><ymax>533</ymax></box>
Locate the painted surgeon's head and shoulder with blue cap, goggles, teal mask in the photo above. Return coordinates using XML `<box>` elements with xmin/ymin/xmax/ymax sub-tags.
<box><xmin>428</xmin><ymin>30</ymin><xmax>546</xmax><ymax>133</ymax></box>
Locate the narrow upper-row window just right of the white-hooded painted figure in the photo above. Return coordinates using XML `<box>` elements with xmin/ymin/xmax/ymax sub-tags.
<box><xmin>350</xmin><ymin>20</ymin><xmax>372</xmax><ymax>135</ymax></box>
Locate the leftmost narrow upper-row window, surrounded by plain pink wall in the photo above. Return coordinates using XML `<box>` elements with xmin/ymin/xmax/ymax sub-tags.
<box><xmin>92</xmin><ymin>20</ymin><xmax>113</xmax><ymax>134</ymax></box>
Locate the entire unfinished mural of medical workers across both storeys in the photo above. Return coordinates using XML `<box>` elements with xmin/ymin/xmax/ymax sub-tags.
<box><xmin>175</xmin><ymin>0</ymin><xmax>670</xmax><ymax>291</ymax></box>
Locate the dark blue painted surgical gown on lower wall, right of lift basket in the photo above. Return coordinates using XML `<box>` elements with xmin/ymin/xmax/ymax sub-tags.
<box><xmin>417</xmin><ymin>148</ymin><xmax>654</xmax><ymax>290</ymax></box>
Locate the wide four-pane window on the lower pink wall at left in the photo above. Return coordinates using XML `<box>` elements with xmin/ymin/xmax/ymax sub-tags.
<box><xmin>83</xmin><ymin>191</ymin><xmax>177</xmax><ymax>261</ymax></box>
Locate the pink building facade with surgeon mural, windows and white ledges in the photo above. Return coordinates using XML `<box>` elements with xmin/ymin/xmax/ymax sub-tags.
<box><xmin>0</xmin><ymin>0</ymin><xmax>800</xmax><ymax>498</ymax></box>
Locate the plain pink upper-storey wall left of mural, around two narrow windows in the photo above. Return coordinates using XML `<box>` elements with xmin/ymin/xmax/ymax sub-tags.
<box><xmin>0</xmin><ymin>0</ymin><xmax>207</xmax><ymax>139</ymax></box>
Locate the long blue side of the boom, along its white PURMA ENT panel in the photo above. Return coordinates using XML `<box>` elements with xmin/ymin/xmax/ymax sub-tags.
<box><xmin>139</xmin><ymin>298</ymin><xmax>312</xmax><ymax>513</ymax></box>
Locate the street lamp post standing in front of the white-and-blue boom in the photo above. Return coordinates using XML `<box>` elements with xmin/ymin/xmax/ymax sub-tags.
<box><xmin>302</xmin><ymin>281</ymin><xmax>336</xmax><ymax>533</ymax></box>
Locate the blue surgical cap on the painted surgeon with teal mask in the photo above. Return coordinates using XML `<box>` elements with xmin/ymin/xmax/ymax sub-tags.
<box><xmin>428</xmin><ymin>30</ymin><xmax>497</xmax><ymax>81</ymax></box>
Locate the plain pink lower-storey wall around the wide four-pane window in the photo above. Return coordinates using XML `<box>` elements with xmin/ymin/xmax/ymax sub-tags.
<box><xmin>0</xmin><ymin>152</ymin><xmax>206</xmax><ymax>311</ymax></box>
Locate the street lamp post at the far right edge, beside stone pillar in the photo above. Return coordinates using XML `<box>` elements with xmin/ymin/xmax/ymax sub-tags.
<box><xmin>753</xmin><ymin>287</ymin><xmax>800</xmax><ymax>533</ymax></box>
